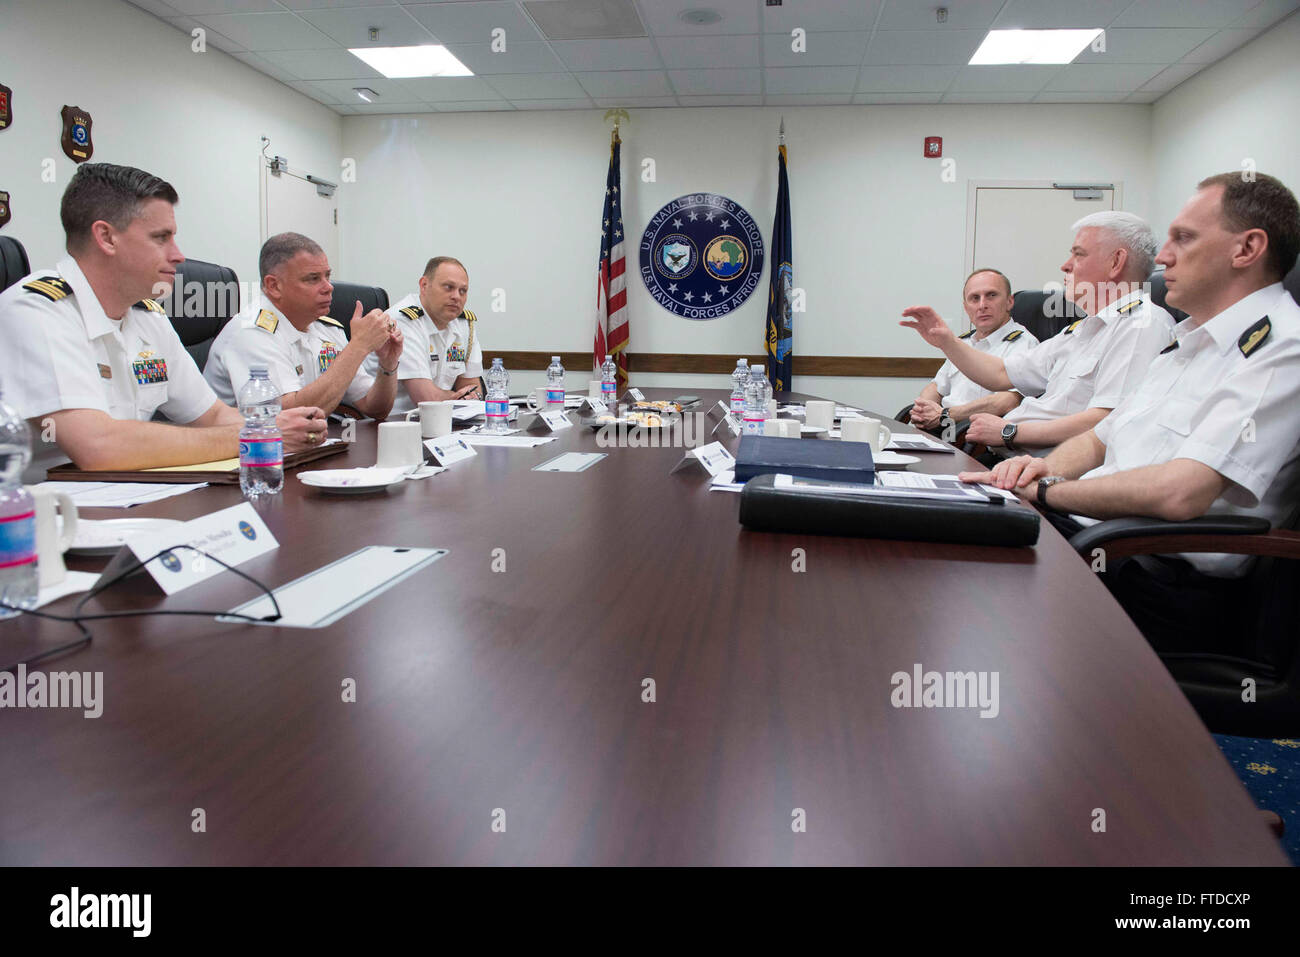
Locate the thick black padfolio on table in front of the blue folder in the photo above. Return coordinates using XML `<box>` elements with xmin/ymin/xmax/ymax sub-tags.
<box><xmin>740</xmin><ymin>475</ymin><xmax>1039</xmax><ymax>546</ymax></box>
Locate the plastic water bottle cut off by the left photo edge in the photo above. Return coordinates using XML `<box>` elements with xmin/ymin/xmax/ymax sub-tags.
<box><xmin>0</xmin><ymin>398</ymin><xmax>40</xmax><ymax>619</ymax></box>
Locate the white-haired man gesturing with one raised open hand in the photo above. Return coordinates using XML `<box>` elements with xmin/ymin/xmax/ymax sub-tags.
<box><xmin>901</xmin><ymin>211</ymin><xmax>1174</xmax><ymax>455</ymax></box>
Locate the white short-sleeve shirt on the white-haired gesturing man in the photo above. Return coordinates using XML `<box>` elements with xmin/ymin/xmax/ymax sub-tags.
<box><xmin>1004</xmin><ymin>290</ymin><xmax>1174</xmax><ymax>423</ymax></box>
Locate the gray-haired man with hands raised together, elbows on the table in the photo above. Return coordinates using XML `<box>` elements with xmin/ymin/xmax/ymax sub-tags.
<box><xmin>203</xmin><ymin>233</ymin><xmax>402</xmax><ymax>421</ymax></box>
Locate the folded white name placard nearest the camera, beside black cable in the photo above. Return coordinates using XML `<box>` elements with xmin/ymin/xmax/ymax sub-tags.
<box><xmin>95</xmin><ymin>502</ymin><xmax>280</xmax><ymax>594</ymax></box>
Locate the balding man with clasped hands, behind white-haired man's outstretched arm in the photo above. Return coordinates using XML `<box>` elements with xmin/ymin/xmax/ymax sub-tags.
<box><xmin>911</xmin><ymin>269</ymin><xmax>1039</xmax><ymax>429</ymax></box>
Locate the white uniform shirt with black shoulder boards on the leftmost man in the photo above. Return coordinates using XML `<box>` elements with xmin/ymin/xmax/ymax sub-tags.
<box><xmin>0</xmin><ymin>256</ymin><xmax>217</xmax><ymax>481</ymax></box>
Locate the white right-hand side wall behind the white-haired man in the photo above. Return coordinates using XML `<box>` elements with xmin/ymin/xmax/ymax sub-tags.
<box><xmin>1152</xmin><ymin>13</ymin><xmax>1300</xmax><ymax>230</ymax></box>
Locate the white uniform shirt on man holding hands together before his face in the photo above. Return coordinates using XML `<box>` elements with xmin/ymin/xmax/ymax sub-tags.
<box><xmin>203</xmin><ymin>293</ymin><xmax>374</xmax><ymax>406</ymax></box>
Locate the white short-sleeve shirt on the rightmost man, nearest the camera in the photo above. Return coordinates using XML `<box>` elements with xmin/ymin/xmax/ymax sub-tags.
<box><xmin>1076</xmin><ymin>282</ymin><xmax>1300</xmax><ymax>577</ymax></box>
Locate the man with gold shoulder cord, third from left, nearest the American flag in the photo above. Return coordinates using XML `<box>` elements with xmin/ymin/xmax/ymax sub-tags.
<box><xmin>377</xmin><ymin>256</ymin><xmax>484</xmax><ymax>412</ymax></box>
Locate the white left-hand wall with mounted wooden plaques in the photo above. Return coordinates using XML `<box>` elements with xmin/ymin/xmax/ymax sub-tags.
<box><xmin>0</xmin><ymin>0</ymin><xmax>342</xmax><ymax>291</ymax></box>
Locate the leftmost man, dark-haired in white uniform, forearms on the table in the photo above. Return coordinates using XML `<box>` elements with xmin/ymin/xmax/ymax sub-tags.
<box><xmin>0</xmin><ymin>163</ymin><xmax>325</xmax><ymax>481</ymax></box>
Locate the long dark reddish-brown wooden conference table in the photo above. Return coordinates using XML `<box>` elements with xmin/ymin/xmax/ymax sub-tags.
<box><xmin>0</xmin><ymin>389</ymin><xmax>1287</xmax><ymax>865</ymax></box>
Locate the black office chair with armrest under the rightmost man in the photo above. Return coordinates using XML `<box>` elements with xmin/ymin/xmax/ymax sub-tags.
<box><xmin>1070</xmin><ymin>516</ymin><xmax>1300</xmax><ymax>737</ymax></box>
